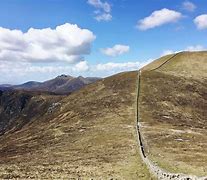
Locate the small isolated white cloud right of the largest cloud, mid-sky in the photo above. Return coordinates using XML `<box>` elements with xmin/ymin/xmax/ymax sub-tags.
<box><xmin>101</xmin><ymin>44</ymin><xmax>130</xmax><ymax>57</ymax></box>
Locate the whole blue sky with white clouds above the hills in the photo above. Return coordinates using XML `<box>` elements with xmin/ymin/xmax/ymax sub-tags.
<box><xmin>0</xmin><ymin>0</ymin><xmax>207</xmax><ymax>84</ymax></box>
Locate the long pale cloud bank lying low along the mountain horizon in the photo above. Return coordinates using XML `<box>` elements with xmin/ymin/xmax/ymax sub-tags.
<box><xmin>0</xmin><ymin>60</ymin><xmax>152</xmax><ymax>84</ymax></box>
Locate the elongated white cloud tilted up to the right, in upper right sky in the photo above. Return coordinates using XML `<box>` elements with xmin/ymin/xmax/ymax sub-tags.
<box><xmin>137</xmin><ymin>8</ymin><xmax>183</xmax><ymax>30</ymax></box>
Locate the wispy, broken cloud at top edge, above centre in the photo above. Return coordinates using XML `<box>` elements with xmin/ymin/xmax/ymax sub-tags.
<box><xmin>88</xmin><ymin>0</ymin><xmax>112</xmax><ymax>21</ymax></box>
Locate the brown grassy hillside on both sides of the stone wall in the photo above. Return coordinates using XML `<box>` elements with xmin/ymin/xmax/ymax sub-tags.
<box><xmin>0</xmin><ymin>52</ymin><xmax>207</xmax><ymax>180</ymax></box>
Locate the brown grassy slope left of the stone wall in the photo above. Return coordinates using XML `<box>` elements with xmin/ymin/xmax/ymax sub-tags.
<box><xmin>0</xmin><ymin>72</ymin><xmax>150</xmax><ymax>180</ymax></box>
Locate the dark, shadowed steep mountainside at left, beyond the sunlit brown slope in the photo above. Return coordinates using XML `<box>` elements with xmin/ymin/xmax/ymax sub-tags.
<box><xmin>0</xmin><ymin>90</ymin><xmax>64</xmax><ymax>135</ymax></box>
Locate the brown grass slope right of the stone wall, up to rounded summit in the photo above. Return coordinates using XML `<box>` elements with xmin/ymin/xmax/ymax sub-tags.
<box><xmin>139</xmin><ymin>52</ymin><xmax>207</xmax><ymax>176</ymax></box>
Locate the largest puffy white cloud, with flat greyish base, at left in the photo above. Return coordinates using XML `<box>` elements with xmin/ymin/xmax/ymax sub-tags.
<box><xmin>0</xmin><ymin>23</ymin><xmax>95</xmax><ymax>63</ymax></box>
